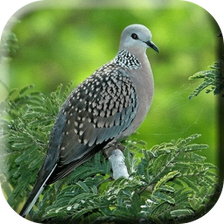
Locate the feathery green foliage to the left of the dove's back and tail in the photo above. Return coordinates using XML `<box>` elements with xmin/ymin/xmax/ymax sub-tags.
<box><xmin>0</xmin><ymin>85</ymin><xmax>70</xmax><ymax>209</ymax></box>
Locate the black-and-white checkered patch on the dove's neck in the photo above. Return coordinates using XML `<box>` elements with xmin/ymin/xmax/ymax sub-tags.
<box><xmin>114</xmin><ymin>50</ymin><xmax>141</xmax><ymax>69</ymax></box>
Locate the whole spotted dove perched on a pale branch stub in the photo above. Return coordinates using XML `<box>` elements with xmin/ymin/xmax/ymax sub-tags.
<box><xmin>19</xmin><ymin>24</ymin><xmax>158</xmax><ymax>220</ymax></box>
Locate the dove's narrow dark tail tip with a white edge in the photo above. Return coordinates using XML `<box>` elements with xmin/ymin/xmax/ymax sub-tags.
<box><xmin>19</xmin><ymin>164</ymin><xmax>57</xmax><ymax>222</ymax></box>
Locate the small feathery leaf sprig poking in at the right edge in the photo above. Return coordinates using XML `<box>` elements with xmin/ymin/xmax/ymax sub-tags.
<box><xmin>189</xmin><ymin>60</ymin><xmax>224</xmax><ymax>99</ymax></box>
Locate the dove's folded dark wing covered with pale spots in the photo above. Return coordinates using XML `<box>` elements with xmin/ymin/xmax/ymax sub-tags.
<box><xmin>44</xmin><ymin>63</ymin><xmax>138</xmax><ymax>184</ymax></box>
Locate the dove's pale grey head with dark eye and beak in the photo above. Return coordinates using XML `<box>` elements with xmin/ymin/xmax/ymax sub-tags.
<box><xmin>119</xmin><ymin>24</ymin><xmax>159</xmax><ymax>53</ymax></box>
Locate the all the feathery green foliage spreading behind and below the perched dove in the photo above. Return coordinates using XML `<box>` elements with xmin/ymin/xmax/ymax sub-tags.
<box><xmin>0</xmin><ymin>85</ymin><xmax>223</xmax><ymax>224</ymax></box>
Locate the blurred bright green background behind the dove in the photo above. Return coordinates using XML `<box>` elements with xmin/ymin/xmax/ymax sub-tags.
<box><xmin>0</xmin><ymin>3</ymin><xmax>218</xmax><ymax>168</ymax></box>
